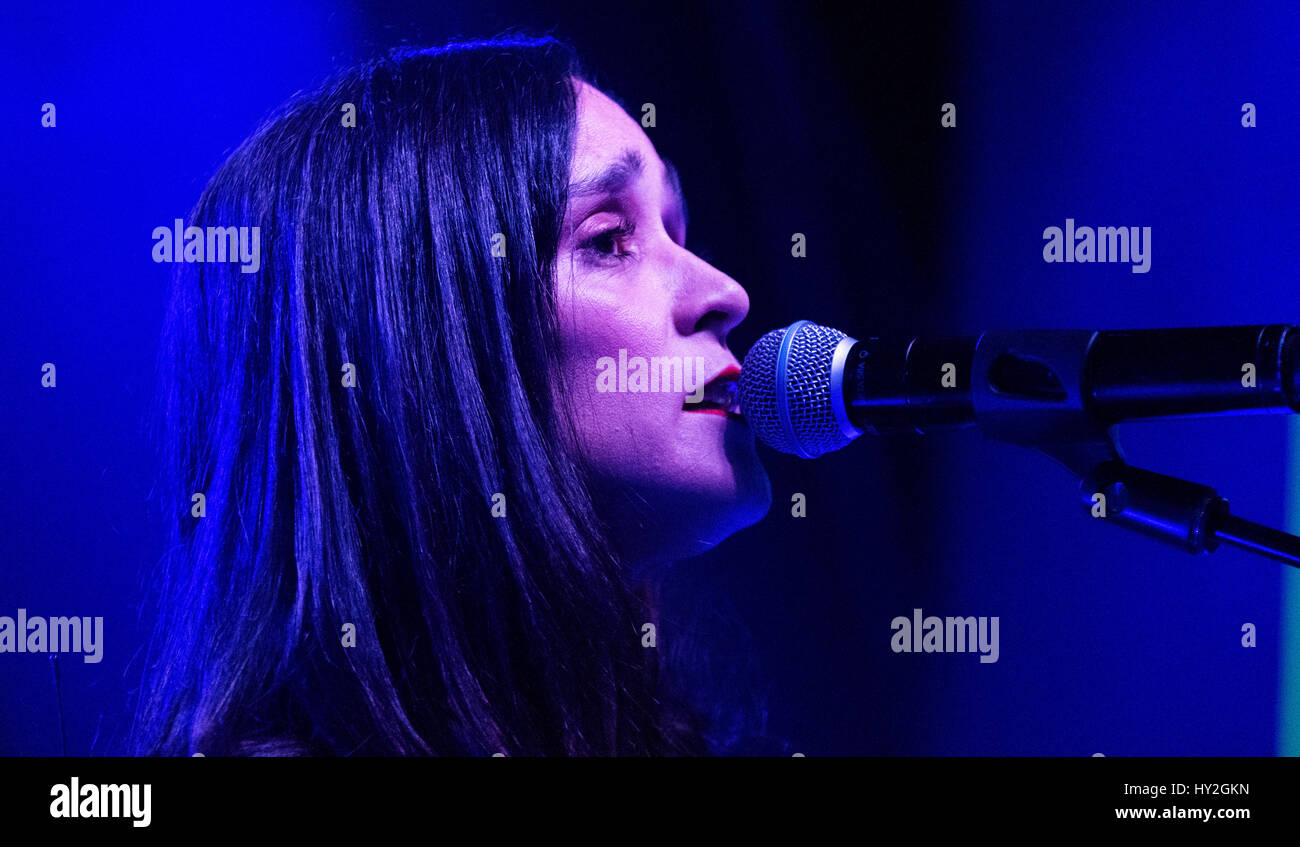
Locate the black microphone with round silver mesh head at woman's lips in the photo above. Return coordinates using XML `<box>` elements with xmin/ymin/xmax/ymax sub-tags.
<box><xmin>740</xmin><ymin>321</ymin><xmax>1300</xmax><ymax>459</ymax></box>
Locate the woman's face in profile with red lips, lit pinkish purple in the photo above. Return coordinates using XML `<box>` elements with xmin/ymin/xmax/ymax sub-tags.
<box><xmin>556</xmin><ymin>83</ymin><xmax>771</xmax><ymax>563</ymax></box>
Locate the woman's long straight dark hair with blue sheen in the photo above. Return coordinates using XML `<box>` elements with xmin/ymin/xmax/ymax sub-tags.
<box><xmin>134</xmin><ymin>38</ymin><xmax>707</xmax><ymax>755</ymax></box>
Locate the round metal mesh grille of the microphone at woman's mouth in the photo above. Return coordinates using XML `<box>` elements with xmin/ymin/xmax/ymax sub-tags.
<box><xmin>740</xmin><ymin>322</ymin><xmax>852</xmax><ymax>459</ymax></box>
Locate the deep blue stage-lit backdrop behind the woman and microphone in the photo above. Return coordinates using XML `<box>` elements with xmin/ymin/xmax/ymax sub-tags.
<box><xmin>0</xmin><ymin>0</ymin><xmax>1300</xmax><ymax>756</ymax></box>
